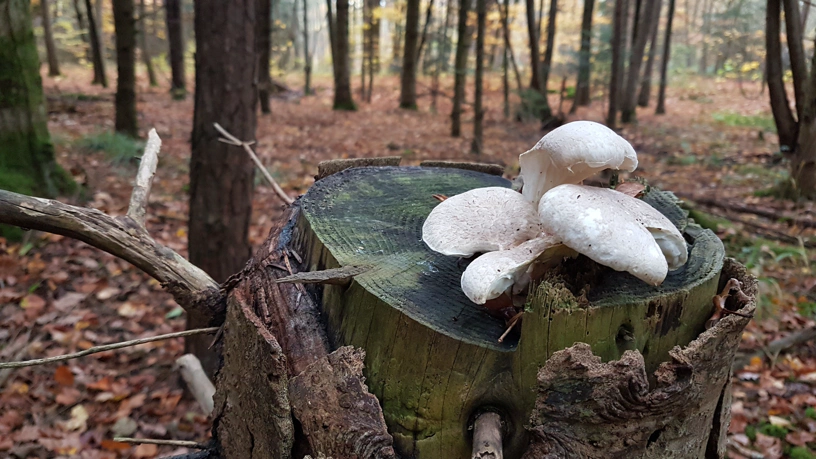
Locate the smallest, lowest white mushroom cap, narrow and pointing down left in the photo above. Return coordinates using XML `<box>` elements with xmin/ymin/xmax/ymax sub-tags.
<box><xmin>461</xmin><ymin>236</ymin><xmax>554</xmax><ymax>304</ymax></box>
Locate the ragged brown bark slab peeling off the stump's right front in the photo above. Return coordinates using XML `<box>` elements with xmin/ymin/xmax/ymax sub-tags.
<box><xmin>524</xmin><ymin>260</ymin><xmax>757</xmax><ymax>459</ymax></box>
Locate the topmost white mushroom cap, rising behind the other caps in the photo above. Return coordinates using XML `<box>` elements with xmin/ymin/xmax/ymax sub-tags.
<box><xmin>519</xmin><ymin>121</ymin><xmax>638</xmax><ymax>206</ymax></box>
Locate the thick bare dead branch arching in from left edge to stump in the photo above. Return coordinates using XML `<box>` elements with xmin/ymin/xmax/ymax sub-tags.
<box><xmin>0</xmin><ymin>190</ymin><xmax>224</xmax><ymax>317</ymax></box>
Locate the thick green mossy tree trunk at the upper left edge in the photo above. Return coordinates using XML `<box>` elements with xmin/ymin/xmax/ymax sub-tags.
<box><xmin>0</xmin><ymin>0</ymin><xmax>73</xmax><ymax>211</ymax></box>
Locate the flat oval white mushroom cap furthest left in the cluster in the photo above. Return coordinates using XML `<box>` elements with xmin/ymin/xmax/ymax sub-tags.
<box><xmin>422</xmin><ymin>187</ymin><xmax>540</xmax><ymax>257</ymax></box>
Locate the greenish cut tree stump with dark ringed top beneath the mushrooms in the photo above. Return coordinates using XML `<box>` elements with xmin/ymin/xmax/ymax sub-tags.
<box><xmin>291</xmin><ymin>167</ymin><xmax>732</xmax><ymax>458</ymax></box>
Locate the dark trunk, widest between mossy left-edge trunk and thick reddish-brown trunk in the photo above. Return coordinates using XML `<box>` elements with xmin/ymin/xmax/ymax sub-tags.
<box><xmin>113</xmin><ymin>0</ymin><xmax>139</xmax><ymax>137</ymax></box>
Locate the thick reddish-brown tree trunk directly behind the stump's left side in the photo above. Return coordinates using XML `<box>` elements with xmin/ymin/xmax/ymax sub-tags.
<box><xmin>186</xmin><ymin>0</ymin><xmax>258</xmax><ymax>375</ymax></box>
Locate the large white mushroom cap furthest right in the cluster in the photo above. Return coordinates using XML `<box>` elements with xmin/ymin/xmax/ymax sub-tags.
<box><xmin>538</xmin><ymin>185</ymin><xmax>688</xmax><ymax>285</ymax></box>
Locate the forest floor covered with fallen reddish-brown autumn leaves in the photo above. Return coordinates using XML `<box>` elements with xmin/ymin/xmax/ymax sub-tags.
<box><xmin>0</xmin><ymin>69</ymin><xmax>816</xmax><ymax>459</ymax></box>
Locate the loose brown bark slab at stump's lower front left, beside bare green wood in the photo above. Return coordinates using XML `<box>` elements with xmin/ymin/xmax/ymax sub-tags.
<box><xmin>289</xmin><ymin>346</ymin><xmax>396</xmax><ymax>459</ymax></box>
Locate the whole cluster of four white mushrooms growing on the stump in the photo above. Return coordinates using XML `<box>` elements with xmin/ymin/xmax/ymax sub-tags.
<box><xmin>422</xmin><ymin>121</ymin><xmax>688</xmax><ymax>304</ymax></box>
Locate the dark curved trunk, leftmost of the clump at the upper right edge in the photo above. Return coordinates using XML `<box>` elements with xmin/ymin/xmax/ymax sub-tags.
<box><xmin>765</xmin><ymin>0</ymin><xmax>799</xmax><ymax>152</ymax></box>
